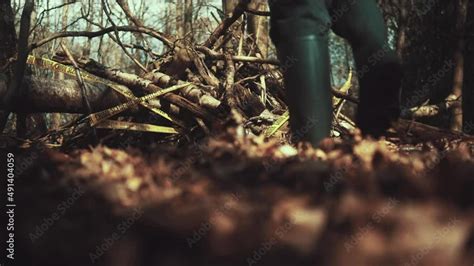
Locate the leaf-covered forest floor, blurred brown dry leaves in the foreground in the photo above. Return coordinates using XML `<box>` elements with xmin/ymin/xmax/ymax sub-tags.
<box><xmin>6</xmin><ymin>125</ymin><xmax>474</xmax><ymax>266</ymax></box>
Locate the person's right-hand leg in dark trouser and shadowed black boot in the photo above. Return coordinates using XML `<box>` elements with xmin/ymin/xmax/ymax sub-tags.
<box><xmin>331</xmin><ymin>0</ymin><xmax>402</xmax><ymax>137</ymax></box>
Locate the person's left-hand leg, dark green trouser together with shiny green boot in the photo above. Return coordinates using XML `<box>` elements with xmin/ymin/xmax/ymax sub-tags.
<box><xmin>270</xmin><ymin>0</ymin><xmax>332</xmax><ymax>145</ymax></box>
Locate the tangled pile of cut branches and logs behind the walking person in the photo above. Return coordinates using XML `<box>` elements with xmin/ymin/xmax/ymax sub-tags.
<box><xmin>0</xmin><ymin>0</ymin><xmax>470</xmax><ymax>148</ymax></box>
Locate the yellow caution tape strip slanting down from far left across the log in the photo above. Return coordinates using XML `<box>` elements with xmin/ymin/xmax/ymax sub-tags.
<box><xmin>26</xmin><ymin>55</ymin><xmax>174</xmax><ymax>122</ymax></box>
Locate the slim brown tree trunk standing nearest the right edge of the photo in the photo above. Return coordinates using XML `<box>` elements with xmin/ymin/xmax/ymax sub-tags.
<box><xmin>451</xmin><ymin>0</ymin><xmax>469</xmax><ymax>131</ymax></box>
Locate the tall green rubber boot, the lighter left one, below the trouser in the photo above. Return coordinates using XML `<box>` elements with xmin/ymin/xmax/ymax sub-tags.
<box><xmin>278</xmin><ymin>35</ymin><xmax>332</xmax><ymax>146</ymax></box>
